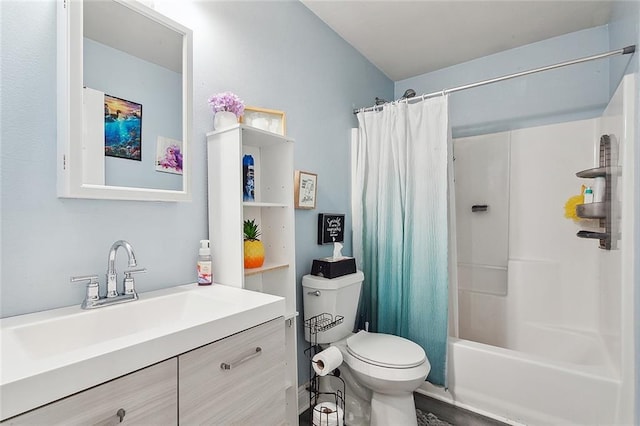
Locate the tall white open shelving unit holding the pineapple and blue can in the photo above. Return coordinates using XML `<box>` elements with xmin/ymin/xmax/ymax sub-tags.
<box><xmin>207</xmin><ymin>124</ymin><xmax>298</xmax><ymax>425</ymax></box>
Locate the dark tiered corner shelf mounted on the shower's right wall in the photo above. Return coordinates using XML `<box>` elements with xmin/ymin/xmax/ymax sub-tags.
<box><xmin>576</xmin><ymin>135</ymin><xmax>620</xmax><ymax>250</ymax></box>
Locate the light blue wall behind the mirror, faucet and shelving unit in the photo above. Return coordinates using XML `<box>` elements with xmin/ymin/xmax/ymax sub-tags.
<box><xmin>0</xmin><ymin>0</ymin><xmax>393</xmax><ymax>390</ymax></box>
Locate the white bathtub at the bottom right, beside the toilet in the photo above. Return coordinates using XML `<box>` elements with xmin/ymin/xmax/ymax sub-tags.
<box><xmin>417</xmin><ymin>336</ymin><xmax>625</xmax><ymax>425</ymax></box>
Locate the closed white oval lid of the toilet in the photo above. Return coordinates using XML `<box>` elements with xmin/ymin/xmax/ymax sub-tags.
<box><xmin>347</xmin><ymin>331</ymin><xmax>427</xmax><ymax>368</ymax></box>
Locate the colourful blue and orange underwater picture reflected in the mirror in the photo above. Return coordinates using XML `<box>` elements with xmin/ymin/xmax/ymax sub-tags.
<box><xmin>104</xmin><ymin>94</ymin><xmax>142</xmax><ymax>161</ymax></box>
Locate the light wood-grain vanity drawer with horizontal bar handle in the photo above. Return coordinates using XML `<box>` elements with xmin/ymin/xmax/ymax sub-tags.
<box><xmin>178</xmin><ymin>318</ymin><xmax>285</xmax><ymax>425</ymax></box>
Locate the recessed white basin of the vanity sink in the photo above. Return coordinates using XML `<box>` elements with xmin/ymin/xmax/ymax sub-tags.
<box><xmin>10</xmin><ymin>292</ymin><xmax>235</xmax><ymax>358</ymax></box>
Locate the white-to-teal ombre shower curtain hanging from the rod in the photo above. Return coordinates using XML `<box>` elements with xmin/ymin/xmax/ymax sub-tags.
<box><xmin>352</xmin><ymin>96</ymin><xmax>450</xmax><ymax>386</ymax></box>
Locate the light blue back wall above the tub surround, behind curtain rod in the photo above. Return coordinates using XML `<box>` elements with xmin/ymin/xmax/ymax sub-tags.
<box><xmin>395</xmin><ymin>26</ymin><xmax>616</xmax><ymax>137</ymax></box>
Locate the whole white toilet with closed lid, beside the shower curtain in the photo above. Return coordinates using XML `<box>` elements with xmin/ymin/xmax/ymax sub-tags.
<box><xmin>302</xmin><ymin>271</ymin><xmax>431</xmax><ymax>426</ymax></box>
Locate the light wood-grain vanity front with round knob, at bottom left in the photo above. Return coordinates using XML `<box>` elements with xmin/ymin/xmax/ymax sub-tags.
<box><xmin>2</xmin><ymin>358</ymin><xmax>178</xmax><ymax>426</ymax></box>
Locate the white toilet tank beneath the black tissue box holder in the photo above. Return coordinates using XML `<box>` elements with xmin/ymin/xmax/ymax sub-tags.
<box><xmin>302</xmin><ymin>271</ymin><xmax>364</xmax><ymax>343</ymax></box>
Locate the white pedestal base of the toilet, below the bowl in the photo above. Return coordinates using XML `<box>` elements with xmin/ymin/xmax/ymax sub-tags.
<box><xmin>371</xmin><ymin>392</ymin><xmax>418</xmax><ymax>426</ymax></box>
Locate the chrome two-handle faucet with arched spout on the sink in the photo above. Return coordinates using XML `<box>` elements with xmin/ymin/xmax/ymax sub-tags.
<box><xmin>71</xmin><ymin>240</ymin><xmax>147</xmax><ymax>309</ymax></box>
